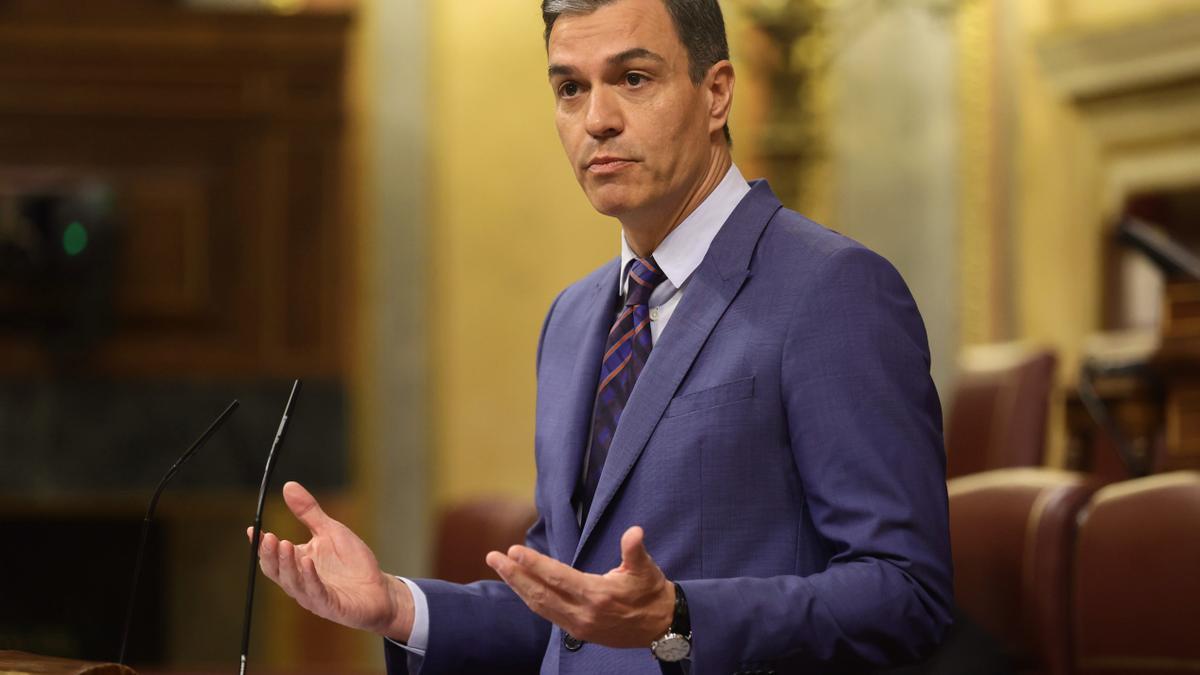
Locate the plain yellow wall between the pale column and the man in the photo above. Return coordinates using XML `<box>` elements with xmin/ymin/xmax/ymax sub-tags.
<box><xmin>428</xmin><ymin>0</ymin><xmax>768</xmax><ymax>504</ymax></box>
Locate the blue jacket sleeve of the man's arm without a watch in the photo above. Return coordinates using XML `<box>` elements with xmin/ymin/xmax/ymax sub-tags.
<box><xmin>384</xmin><ymin>294</ymin><xmax>562</xmax><ymax>675</ymax></box>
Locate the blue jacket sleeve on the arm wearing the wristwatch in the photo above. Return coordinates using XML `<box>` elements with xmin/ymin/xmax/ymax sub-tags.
<box><xmin>682</xmin><ymin>246</ymin><xmax>953</xmax><ymax>674</ymax></box>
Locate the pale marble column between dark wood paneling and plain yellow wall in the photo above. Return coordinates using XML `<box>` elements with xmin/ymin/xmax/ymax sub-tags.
<box><xmin>349</xmin><ymin>0</ymin><xmax>431</xmax><ymax>590</ymax></box>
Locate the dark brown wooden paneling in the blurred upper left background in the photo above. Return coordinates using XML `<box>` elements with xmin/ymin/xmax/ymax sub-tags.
<box><xmin>0</xmin><ymin>0</ymin><xmax>353</xmax><ymax>377</ymax></box>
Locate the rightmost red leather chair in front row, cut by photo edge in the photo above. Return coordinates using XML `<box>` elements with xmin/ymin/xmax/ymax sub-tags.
<box><xmin>1073</xmin><ymin>471</ymin><xmax>1200</xmax><ymax>675</ymax></box>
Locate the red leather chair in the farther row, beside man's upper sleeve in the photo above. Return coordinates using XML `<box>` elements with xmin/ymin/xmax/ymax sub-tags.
<box><xmin>946</xmin><ymin>344</ymin><xmax>1057</xmax><ymax>478</ymax></box>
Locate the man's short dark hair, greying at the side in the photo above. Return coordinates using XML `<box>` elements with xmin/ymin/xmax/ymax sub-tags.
<box><xmin>541</xmin><ymin>0</ymin><xmax>732</xmax><ymax>143</ymax></box>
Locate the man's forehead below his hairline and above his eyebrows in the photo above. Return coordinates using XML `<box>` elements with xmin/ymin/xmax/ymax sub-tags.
<box><xmin>547</xmin><ymin>0</ymin><xmax>683</xmax><ymax>65</ymax></box>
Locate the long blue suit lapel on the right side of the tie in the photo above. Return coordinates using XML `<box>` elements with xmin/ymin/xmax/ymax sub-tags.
<box><xmin>571</xmin><ymin>181</ymin><xmax>780</xmax><ymax>563</ymax></box>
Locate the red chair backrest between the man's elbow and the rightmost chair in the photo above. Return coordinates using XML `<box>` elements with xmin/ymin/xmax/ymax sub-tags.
<box><xmin>947</xmin><ymin>468</ymin><xmax>1096</xmax><ymax>675</ymax></box>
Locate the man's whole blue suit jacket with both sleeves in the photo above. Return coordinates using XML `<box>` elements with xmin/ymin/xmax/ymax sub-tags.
<box><xmin>388</xmin><ymin>181</ymin><xmax>952</xmax><ymax>675</ymax></box>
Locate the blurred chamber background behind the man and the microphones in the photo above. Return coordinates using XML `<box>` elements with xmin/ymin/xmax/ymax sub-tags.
<box><xmin>0</xmin><ymin>0</ymin><xmax>1200</xmax><ymax>673</ymax></box>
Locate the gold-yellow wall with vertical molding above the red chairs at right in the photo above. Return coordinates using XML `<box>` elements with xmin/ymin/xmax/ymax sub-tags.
<box><xmin>956</xmin><ymin>0</ymin><xmax>1200</xmax><ymax>465</ymax></box>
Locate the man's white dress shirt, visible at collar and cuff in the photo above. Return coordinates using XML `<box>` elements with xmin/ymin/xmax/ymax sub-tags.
<box><xmin>392</xmin><ymin>165</ymin><xmax>750</xmax><ymax>674</ymax></box>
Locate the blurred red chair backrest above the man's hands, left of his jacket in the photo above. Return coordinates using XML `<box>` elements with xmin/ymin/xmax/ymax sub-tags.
<box><xmin>433</xmin><ymin>496</ymin><xmax>538</xmax><ymax>584</ymax></box>
